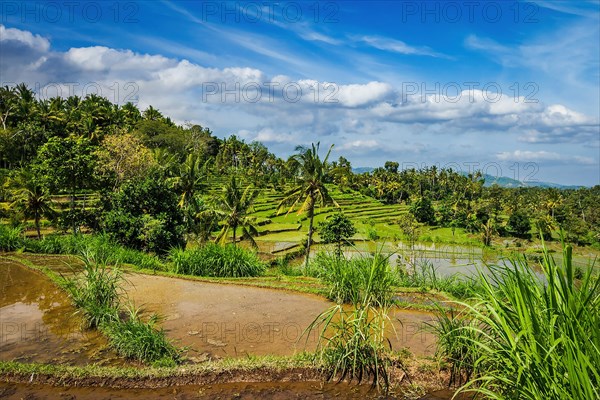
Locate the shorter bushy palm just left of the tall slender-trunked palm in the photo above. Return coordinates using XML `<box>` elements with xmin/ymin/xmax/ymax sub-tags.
<box><xmin>210</xmin><ymin>176</ymin><xmax>258</xmax><ymax>247</ymax></box>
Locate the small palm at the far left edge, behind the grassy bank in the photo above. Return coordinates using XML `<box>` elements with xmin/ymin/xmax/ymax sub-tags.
<box><xmin>5</xmin><ymin>170</ymin><xmax>55</xmax><ymax>239</ymax></box>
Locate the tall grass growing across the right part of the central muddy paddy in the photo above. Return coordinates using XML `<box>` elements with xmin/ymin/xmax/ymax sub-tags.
<box><xmin>305</xmin><ymin>253</ymin><xmax>394</xmax><ymax>390</ymax></box>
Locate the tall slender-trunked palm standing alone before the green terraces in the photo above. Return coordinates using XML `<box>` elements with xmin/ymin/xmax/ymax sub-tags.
<box><xmin>277</xmin><ymin>143</ymin><xmax>339</xmax><ymax>267</ymax></box>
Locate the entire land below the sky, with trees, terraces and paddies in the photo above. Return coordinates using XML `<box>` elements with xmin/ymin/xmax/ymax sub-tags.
<box><xmin>0</xmin><ymin>85</ymin><xmax>600</xmax><ymax>400</ymax></box>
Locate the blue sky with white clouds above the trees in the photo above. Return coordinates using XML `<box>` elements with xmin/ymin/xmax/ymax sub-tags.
<box><xmin>0</xmin><ymin>0</ymin><xmax>600</xmax><ymax>185</ymax></box>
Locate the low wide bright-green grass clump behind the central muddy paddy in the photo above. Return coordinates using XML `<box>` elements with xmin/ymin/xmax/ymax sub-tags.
<box><xmin>169</xmin><ymin>243</ymin><xmax>266</xmax><ymax>278</ymax></box>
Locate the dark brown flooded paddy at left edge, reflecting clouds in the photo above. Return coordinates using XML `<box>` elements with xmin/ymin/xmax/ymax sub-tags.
<box><xmin>0</xmin><ymin>258</ymin><xmax>120</xmax><ymax>365</ymax></box>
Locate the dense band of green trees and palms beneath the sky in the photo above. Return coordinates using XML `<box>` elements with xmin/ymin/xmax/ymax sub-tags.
<box><xmin>0</xmin><ymin>84</ymin><xmax>600</xmax><ymax>254</ymax></box>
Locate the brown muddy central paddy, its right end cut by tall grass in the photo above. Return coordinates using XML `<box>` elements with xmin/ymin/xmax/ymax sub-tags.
<box><xmin>127</xmin><ymin>274</ymin><xmax>435</xmax><ymax>361</ymax></box>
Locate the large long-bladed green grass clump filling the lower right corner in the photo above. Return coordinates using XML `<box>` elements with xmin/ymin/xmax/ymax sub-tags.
<box><xmin>439</xmin><ymin>239</ymin><xmax>600</xmax><ymax>400</ymax></box>
